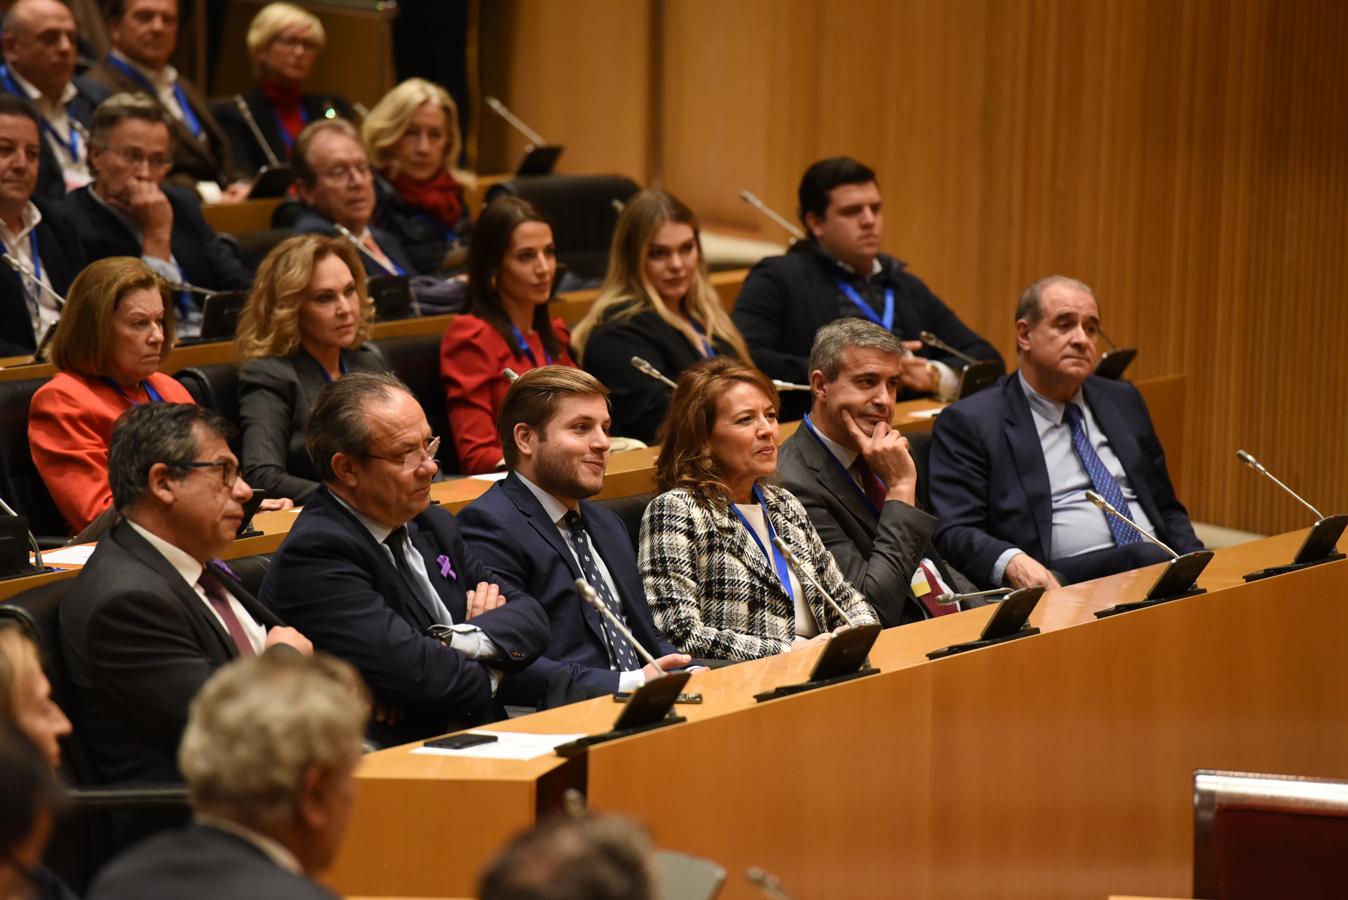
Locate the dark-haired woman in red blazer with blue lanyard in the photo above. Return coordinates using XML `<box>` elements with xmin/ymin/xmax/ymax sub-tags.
<box><xmin>439</xmin><ymin>197</ymin><xmax>576</xmax><ymax>474</ymax></box>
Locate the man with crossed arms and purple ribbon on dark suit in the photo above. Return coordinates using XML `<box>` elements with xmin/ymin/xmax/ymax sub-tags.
<box><xmin>262</xmin><ymin>372</ymin><xmax>547</xmax><ymax>745</ymax></box>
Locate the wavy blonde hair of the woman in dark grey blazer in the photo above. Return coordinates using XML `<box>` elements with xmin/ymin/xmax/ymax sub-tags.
<box><xmin>237</xmin><ymin>234</ymin><xmax>375</xmax><ymax>361</ymax></box>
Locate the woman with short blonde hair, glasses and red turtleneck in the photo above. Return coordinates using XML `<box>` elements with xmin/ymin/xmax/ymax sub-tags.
<box><xmin>214</xmin><ymin>3</ymin><xmax>355</xmax><ymax>174</ymax></box>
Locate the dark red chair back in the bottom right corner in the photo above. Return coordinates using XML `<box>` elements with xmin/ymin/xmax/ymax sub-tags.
<box><xmin>1193</xmin><ymin>769</ymin><xmax>1348</xmax><ymax>900</ymax></box>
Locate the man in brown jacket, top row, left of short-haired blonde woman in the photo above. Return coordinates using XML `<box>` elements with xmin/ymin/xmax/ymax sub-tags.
<box><xmin>88</xmin><ymin>0</ymin><xmax>248</xmax><ymax>203</ymax></box>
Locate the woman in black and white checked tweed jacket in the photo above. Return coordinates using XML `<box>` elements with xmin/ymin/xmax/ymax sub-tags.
<box><xmin>639</xmin><ymin>357</ymin><xmax>876</xmax><ymax>659</ymax></box>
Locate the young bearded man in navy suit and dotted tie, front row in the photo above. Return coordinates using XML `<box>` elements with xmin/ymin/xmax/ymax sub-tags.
<box><xmin>458</xmin><ymin>365</ymin><xmax>692</xmax><ymax>706</ymax></box>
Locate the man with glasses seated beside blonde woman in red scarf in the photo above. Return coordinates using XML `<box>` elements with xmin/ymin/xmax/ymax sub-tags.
<box><xmin>292</xmin><ymin>119</ymin><xmax>417</xmax><ymax>276</ymax></box>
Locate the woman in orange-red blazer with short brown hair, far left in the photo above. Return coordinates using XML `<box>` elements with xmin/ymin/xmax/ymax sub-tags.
<box><xmin>28</xmin><ymin>256</ymin><xmax>193</xmax><ymax>532</ymax></box>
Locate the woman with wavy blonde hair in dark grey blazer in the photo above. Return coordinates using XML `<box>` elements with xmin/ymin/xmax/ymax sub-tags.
<box><xmin>239</xmin><ymin>234</ymin><xmax>387</xmax><ymax>503</ymax></box>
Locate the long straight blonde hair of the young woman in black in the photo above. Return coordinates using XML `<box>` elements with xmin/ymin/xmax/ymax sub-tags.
<box><xmin>572</xmin><ymin>190</ymin><xmax>749</xmax><ymax>362</ymax></box>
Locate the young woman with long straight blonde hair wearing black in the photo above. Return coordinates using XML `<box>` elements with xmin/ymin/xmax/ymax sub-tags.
<box><xmin>573</xmin><ymin>190</ymin><xmax>749</xmax><ymax>443</ymax></box>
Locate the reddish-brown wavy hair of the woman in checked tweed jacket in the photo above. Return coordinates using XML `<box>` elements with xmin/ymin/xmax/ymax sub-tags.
<box><xmin>655</xmin><ymin>356</ymin><xmax>782</xmax><ymax>507</ymax></box>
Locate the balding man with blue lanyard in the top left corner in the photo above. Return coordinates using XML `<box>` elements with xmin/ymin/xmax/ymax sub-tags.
<box><xmin>0</xmin><ymin>0</ymin><xmax>108</xmax><ymax>199</ymax></box>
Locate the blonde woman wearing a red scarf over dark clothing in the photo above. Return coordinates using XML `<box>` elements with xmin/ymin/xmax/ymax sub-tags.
<box><xmin>360</xmin><ymin>78</ymin><xmax>473</xmax><ymax>274</ymax></box>
